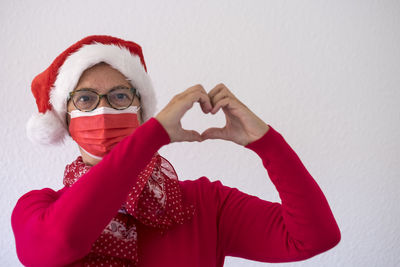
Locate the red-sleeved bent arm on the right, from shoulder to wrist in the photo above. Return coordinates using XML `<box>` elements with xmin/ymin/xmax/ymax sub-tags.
<box><xmin>218</xmin><ymin>125</ymin><xmax>340</xmax><ymax>262</ymax></box>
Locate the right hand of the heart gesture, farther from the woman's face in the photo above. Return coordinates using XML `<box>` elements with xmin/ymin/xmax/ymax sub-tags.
<box><xmin>201</xmin><ymin>83</ymin><xmax>270</xmax><ymax>146</ymax></box>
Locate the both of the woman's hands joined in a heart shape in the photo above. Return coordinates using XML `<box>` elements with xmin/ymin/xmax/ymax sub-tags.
<box><xmin>156</xmin><ymin>84</ymin><xmax>269</xmax><ymax>146</ymax></box>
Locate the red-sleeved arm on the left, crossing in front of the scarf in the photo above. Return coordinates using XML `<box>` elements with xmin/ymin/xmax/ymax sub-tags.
<box><xmin>11</xmin><ymin>118</ymin><xmax>170</xmax><ymax>266</ymax></box>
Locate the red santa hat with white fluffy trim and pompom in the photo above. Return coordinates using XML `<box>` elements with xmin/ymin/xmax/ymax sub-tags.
<box><xmin>27</xmin><ymin>35</ymin><xmax>157</xmax><ymax>147</ymax></box>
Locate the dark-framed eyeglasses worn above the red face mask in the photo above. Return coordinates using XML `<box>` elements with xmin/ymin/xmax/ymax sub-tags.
<box><xmin>67</xmin><ymin>87</ymin><xmax>140</xmax><ymax>112</ymax></box>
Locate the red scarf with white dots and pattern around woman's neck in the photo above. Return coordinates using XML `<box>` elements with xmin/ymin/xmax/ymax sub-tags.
<box><xmin>63</xmin><ymin>152</ymin><xmax>195</xmax><ymax>266</ymax></box>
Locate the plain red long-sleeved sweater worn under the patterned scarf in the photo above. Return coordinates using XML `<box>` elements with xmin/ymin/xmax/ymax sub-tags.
<box><xmin>11</xmin><ymin>117</ymin><xmax>340</xmax><ymax>267</ymax></box>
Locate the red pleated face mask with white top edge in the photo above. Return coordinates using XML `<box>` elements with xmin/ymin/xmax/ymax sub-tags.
<box><xmin>69</xmin><ymin>106</ymin><xmax>139</xmax><ymax>159</ymax></box>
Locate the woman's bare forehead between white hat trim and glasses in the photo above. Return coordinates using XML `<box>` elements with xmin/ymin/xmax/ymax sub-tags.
<box><xmin>75</xmin><ymin>62</ymin><xmax>131</xmax><ymax>91</ymax></box>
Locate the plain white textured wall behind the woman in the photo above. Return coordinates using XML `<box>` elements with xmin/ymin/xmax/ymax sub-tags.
<box><xmin>0</xmin><ymin>0</ymin><xmax>400</xmax><ymax>266</ymax></box>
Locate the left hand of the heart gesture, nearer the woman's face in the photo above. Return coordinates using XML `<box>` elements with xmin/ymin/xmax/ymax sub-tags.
<box><xmin>155</xmin><ymin>84</ymin><xmax>212</xmax><ymax>143</ymax></box>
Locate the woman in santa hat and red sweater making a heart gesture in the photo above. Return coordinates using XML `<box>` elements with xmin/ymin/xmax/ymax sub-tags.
<box><xmin>11</xmin><ymin>35</ymin><xmax>341</xmax><ymax>267</ymax></box>
